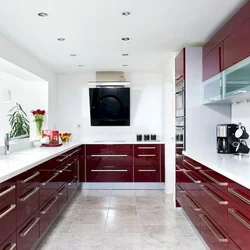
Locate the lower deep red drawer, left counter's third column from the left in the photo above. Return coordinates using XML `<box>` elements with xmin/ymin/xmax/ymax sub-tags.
<box><xmin>39</xmin><ymin>193</ymin><xmax>59</xmax><ymax>235</ymax></box>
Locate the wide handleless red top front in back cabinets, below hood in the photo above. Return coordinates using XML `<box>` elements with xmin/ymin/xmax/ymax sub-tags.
<box><xmin>86</xmin><ymin>144</ymin><xmax>133</xmax><ymax>155</ymax></box>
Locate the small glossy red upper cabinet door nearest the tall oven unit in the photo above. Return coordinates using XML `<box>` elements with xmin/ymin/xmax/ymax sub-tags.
<box><xmin>202</xmin><ymin>44</ymin><xmax>223</xmax><ymax>81</ymax></box>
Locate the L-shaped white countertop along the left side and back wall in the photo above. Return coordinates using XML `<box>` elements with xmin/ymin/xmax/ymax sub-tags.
<box><xmin>0</xmin><ymin>140</ymin><xmax>164</xmax><ymax>183</ymax></box>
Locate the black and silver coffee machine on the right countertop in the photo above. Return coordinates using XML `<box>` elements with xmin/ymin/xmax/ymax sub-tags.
<box><xmin>216</xmin><ymin>124</ymin><xmax>238</xmax><ymax>154</ymax></box>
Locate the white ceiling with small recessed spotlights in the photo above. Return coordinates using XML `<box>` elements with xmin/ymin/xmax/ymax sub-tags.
<box><xmin>0</xmin><ymin>0</ymin><xmax>247</xmax><ymax>72</ymax></box>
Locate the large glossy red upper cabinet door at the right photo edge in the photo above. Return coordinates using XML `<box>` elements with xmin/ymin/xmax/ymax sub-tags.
<box><xmin>224</xmin><ymin>19</ymin><xmax>250</xmax><ymax>69</ymax></box>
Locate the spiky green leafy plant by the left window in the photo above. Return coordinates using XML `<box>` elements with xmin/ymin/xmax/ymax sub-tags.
<box><xmin>8</xmin><ymin>103</ymin><xmax>30</xmax><ymax>138</ymax></box>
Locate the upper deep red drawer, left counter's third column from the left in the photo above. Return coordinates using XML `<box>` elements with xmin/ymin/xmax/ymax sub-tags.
<box><xmin>39</xmin><ymin>172</ymin><xmax>59</xmax><ymax>206</ymax></box>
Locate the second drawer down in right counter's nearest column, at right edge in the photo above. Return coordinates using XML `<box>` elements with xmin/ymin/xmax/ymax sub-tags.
<box><xmin>228</xmin><ymin>200</ymin><xmax>250</xmax><ymax>249</ymax></box>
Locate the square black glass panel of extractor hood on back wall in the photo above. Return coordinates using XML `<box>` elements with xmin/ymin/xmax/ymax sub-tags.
<box><xmin>89</xmin><ymin>87</ymin><xmax>130</xmax><ymax>126</ymax></box>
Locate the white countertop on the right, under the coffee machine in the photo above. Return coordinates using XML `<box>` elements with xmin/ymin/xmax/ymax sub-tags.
<box><xmin>183</xmin><ymin>151</ymin><xmax>250</xmax><ymax>189</ymax></box>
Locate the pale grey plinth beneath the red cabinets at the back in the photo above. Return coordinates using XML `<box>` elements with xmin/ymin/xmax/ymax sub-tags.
<box><xmin>80</xmin><ymin>182</ymin><xmax>165</xmax><ymax>190</ymax></box>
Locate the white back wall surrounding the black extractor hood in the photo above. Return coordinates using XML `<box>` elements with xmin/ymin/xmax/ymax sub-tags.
<box><xmin>58</xmin><ymin>72</ymin><xmax>164</xmax><ymax>143</ymax></box>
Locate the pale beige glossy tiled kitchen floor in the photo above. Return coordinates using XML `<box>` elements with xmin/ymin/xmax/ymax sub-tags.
<box><xmin>36</xmin><ymin>190</ymin><xmax>205</xmax><ymax>250</ymax></box>
